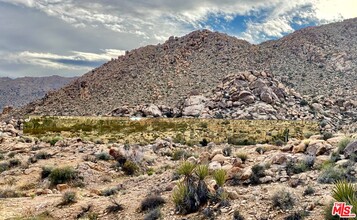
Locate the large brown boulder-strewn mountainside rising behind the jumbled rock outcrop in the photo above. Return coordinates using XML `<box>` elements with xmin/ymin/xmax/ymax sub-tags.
<box><xmin>5</xmin><ymin>19</ymin><xmax>357</xmax><ymax>127</ymax></box>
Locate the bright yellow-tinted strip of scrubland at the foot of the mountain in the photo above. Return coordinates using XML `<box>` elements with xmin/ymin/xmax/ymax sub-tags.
<box><xmin>24</xmin><ymin>116</ymin><xmax>319</xmax><ymax>145</ymax></box>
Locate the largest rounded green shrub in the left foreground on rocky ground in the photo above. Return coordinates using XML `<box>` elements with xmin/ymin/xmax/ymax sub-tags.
<box><xmin>48</xmin><ymin>167</ymin><xmax>78</xmax><ymax>185</ymax></box>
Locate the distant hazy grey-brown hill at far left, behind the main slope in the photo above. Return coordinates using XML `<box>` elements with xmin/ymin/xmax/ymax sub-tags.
<box><xmin>0</xmin><ymin>76</ymin><xmax>75</xmax><ymax>109</ymax></box>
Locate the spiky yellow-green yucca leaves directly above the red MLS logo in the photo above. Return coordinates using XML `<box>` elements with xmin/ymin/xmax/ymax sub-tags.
<box><xmin>332</xmin><ymin>180</ymin><xmax>357</xmax><ymax>213</ymax></box>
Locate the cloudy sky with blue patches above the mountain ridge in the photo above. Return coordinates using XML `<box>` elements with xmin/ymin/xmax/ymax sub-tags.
<box><xmin>0</xmin><ymin>0</ymin><xmax>357</xmax><ymax>77</ymax></box>
